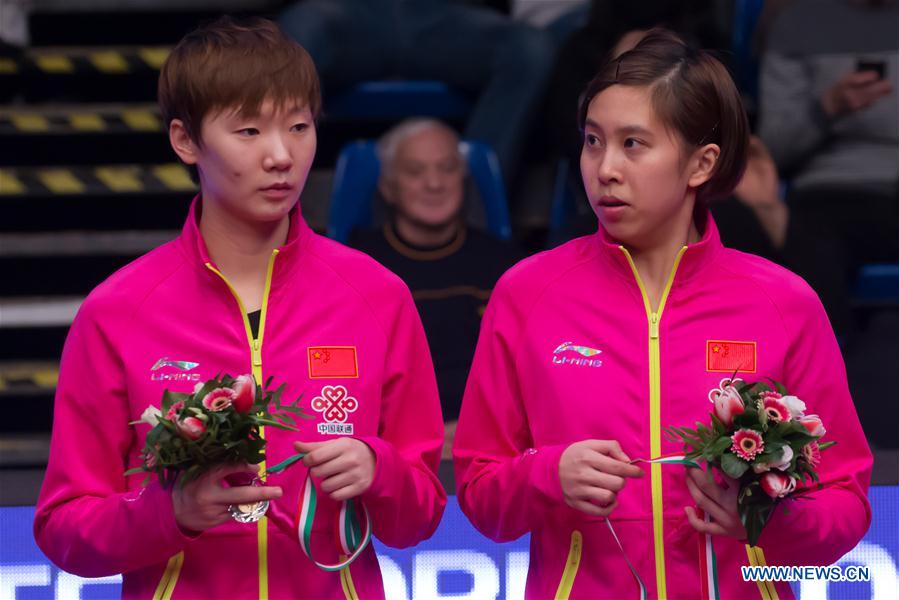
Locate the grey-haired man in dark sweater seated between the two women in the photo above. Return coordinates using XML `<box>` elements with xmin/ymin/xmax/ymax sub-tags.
<box><xmin>350</xmin><ymin>119</ymin><xmax>521</xmax><ymax>458</ymax></box>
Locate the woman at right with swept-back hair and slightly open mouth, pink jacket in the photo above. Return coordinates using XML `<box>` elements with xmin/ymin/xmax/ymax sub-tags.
<box><xmin>454</xmin><ymin>31</ymin><xmax>871</xmax><ymax>598</ymax></box>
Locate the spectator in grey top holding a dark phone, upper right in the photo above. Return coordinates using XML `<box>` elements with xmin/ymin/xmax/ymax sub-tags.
<box><xmin>760</xmin><ymin>0</ymin><xmax>899</xmax><ymax>337</ymax></box>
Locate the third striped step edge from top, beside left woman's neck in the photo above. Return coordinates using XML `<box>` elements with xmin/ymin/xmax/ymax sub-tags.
<box><xmin>0</xmin><ymin>163</ymin><xmax>197</xmax><ymax>198</ymax></box>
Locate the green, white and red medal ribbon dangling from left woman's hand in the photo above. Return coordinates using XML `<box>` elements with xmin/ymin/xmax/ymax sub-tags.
<box><xmin>267</xmin><ymin>453</ymin><xmax>371</xmax><ymax>572</ymax></box>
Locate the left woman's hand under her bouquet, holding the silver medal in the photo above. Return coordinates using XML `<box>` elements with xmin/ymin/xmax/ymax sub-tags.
<box><xmin>172</xmin><ymin>464</ymin><xmax>282</xmax><ymax>535</ymax></box>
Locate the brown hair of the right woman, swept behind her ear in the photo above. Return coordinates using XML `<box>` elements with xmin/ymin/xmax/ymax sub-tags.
<box><xmin>578</xmin><ymin>28</ymin><xmax>749</xmax><ymax>208</ymax></box>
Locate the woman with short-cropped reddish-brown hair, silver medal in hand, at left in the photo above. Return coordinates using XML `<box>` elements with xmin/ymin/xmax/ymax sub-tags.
<box><xmin>34</xmin><ymin>19</ymin><xmax>446</xmax><ymax>600</ymax></box>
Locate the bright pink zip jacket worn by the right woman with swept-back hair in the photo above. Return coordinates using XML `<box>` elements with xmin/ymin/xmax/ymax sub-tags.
<box><xmin>454</xmin><ymin>218</ymin><xmax>872</xmax><ymax>599</ymax></box>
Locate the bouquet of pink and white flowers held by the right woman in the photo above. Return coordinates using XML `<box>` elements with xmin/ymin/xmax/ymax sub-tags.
<box><xmin>666</xmin><ymin>378</ymin><xmax>835</xmax><ymax>546</ymax></box>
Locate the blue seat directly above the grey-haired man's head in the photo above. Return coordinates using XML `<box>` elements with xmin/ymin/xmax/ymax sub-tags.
<box><xmin>325</xmin><ymin>80</ymin><xmax>471</xmax><ymax>120</ymax></box>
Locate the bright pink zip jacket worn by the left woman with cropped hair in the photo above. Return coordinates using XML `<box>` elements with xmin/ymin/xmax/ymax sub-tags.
<box><xmin>34</xmin><ymin>200</ymin><xmax>446</xmax><ymax>600</ymax></box>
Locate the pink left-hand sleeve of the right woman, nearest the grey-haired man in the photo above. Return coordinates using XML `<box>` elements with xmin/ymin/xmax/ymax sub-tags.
<box><xmin>453</xmin><ymin>280</ymin><xmax>565</xmax><ymax>542</ymax></box>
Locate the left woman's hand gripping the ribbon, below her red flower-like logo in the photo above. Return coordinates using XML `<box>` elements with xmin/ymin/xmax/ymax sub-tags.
<box><xmin>293</xmin><ymin>437</ymin><xmax>375</xmax><ymax>502</ymax></box>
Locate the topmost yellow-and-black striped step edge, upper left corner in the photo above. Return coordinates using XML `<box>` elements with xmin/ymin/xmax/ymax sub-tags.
<box><xmin>0</xmin><ymin>46</ymin><xmax>171</xmax><ymax>77</ymax></box>
